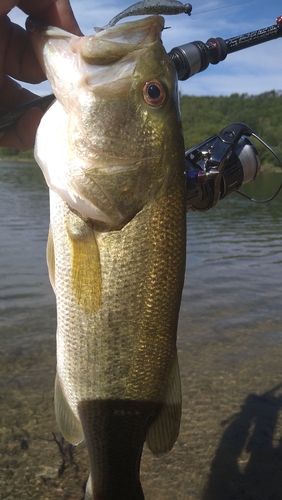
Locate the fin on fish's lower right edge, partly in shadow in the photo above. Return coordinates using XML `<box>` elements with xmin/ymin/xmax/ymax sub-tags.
<box><xmin>146</xmin><ymin>353</ymin><xmax>182</xmax><ymax>456</ymax></box>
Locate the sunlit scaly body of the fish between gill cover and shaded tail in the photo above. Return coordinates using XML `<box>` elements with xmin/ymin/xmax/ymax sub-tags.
<box><xmin>51</xmin><ymin>178</ymin><xmax>185</xmax><ymax>409</ymax></box>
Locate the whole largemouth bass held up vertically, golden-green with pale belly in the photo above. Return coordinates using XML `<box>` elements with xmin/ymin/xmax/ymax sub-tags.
<box><xmin>29</xmin><ymin>16</ymin><xmax>186</xmax><ymax>500</ymax></box>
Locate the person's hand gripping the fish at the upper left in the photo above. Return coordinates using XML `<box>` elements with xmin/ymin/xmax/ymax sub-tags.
<box><xmin>0</xmin><ymin>0</ymin><xmax>81</xmax><ymax>150</ymax></box>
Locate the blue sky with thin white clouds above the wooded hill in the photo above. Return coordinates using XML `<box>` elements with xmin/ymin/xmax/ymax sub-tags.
<box><xmin>10</xmin><ymin>0</ymin><xmax>282</xmax><ymax>96</ymax></box>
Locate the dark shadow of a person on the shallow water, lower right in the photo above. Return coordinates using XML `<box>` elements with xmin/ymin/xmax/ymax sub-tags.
<box><xmin>203</xmin><ymin>383</ymin><xmax>282</xmax><ymax>500</ymax></box>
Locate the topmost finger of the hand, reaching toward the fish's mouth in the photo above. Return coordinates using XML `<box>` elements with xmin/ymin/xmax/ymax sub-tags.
<box><xmin>18</xmin><ymin>0</ymin><xmax>82</xmax><ymax>36</ymax></box>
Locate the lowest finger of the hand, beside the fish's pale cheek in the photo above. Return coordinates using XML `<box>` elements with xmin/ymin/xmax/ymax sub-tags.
<box><xmin>0</xmin><ymin>108</ymin><xmax>43</xmax><ymax>151</ymax></box>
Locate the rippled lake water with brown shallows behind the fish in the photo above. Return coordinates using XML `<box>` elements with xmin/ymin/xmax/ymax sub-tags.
<box><xmin>0</xmin><ymin>162</ymin><xmax>282</xmax><ymax>500</ymax></box>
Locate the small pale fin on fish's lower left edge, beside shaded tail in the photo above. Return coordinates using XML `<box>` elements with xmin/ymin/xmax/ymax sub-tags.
<box><xmin>55</xmin><ymin>375</ymin><xmax>84</xmax><ymax>444</ymax></box>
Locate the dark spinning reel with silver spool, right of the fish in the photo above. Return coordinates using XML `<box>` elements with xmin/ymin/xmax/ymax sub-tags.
<box><xmin>185</xmin><ymin>123</ymin><xmax>282</xmax><ymax>211</ymax></box>
